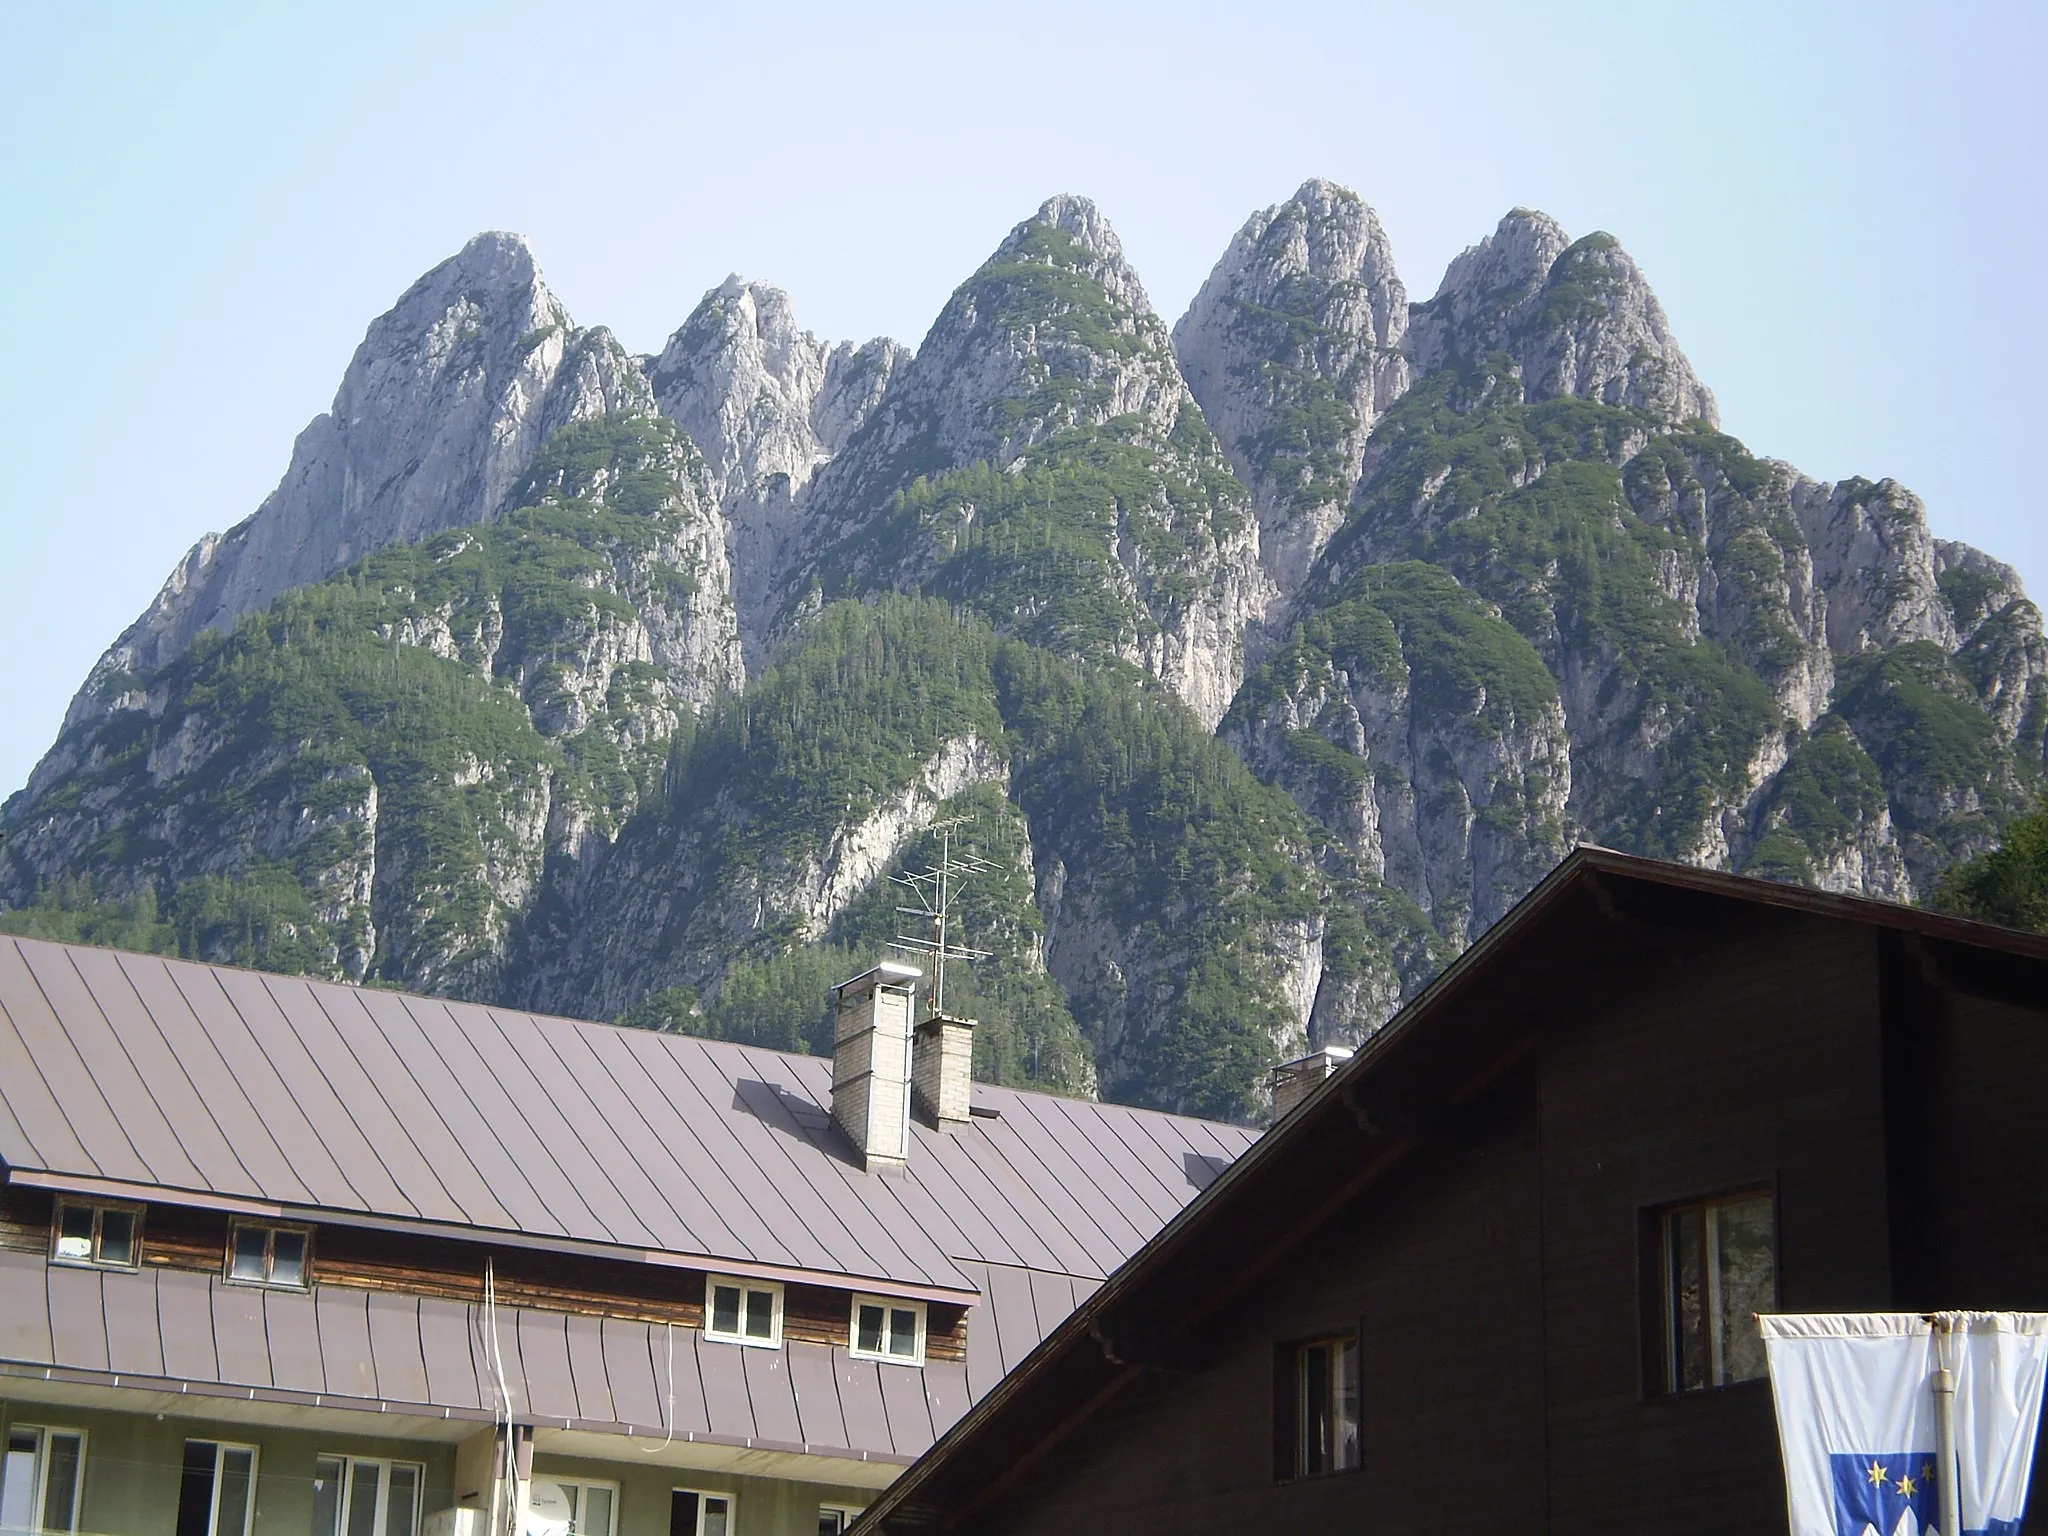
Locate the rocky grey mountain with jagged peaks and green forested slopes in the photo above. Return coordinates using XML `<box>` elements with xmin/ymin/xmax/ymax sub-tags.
<box><xmin>0</xmin><ymin>182</ymin><xmax>2048</xmax><ymax>1116</ymax></box>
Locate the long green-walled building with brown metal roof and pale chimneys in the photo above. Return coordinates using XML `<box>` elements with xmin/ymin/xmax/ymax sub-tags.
<box><xmin>0</xmin><ymin>938</ymin><xmax>1251</xmax><ymax>1536</ymax></box>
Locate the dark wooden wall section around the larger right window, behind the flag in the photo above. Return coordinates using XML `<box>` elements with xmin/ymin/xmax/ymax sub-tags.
<box><xmin>1542</xmin><ymin>911</ymin><xmax>1890</xmax><ymax>1532</ymax></box>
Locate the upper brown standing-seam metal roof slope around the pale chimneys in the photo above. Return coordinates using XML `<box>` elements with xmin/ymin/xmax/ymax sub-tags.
<box><xmin>0</xmin><ymin>938</ymin><xmax>1255</xmax><ymax>1303</ymax></box>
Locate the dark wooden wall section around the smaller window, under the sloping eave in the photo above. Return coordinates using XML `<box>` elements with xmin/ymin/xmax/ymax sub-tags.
<box><xmin>971</xmin><ymin>1075</ymin><xmax>1542</xmax><ymax>1536</ymax></box>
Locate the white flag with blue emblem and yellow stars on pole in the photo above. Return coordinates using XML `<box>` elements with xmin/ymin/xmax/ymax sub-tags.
<box><xmin>1757</xmin><ymin>1313</ymin><xmax>2048</xmax><ymax>1536</ymax></box>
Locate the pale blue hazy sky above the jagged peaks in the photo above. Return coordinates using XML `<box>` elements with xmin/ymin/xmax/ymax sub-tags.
<box><xmin>0</xmin><ymin>0</ymin><xmax>2048</xmax><ymax>795</ymax></box>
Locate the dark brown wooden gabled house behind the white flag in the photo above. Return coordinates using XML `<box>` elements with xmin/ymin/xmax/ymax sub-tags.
<box><xmin>860</xmin><ymin>850</ymin><xmax>2048</xmax><ymax>1536</ymax></box>
